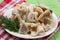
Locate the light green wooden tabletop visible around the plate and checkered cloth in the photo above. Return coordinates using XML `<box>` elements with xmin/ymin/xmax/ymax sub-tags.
<box><xmin>0</xmin><ymin>0</ymin><xmax>60</xmax><ymax>40</ymax></box>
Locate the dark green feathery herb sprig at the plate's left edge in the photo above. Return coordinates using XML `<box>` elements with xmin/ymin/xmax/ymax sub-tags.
<box><xmin>0</xmin><ymin>16</ymin><xmax>19</xmax><ymax>32</ymax></box>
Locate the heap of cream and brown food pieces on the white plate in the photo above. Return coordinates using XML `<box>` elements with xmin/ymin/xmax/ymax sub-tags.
<box><xmin>0</xmin><ymin>3</ymin><xmax>53</xmax><ymax>36</ymax></box>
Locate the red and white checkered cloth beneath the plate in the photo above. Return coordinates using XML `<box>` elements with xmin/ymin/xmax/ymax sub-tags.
<box><xmin>0</xmin><ymin>0</ymin><xmax>60</xmax><ymax>40</ymax></box>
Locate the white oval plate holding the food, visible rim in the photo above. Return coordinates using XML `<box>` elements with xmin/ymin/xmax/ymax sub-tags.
<box><xmin>4</xmin><ymin>8</ymin><xmax>58</xmax><ymax>39</ymax></box>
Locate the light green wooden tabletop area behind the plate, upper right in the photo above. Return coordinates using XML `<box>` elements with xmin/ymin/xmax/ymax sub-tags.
<box><xmin>27</xmin><ymin>0</ymin><xmax>60</xmax><ymax>16</ymax></box>
